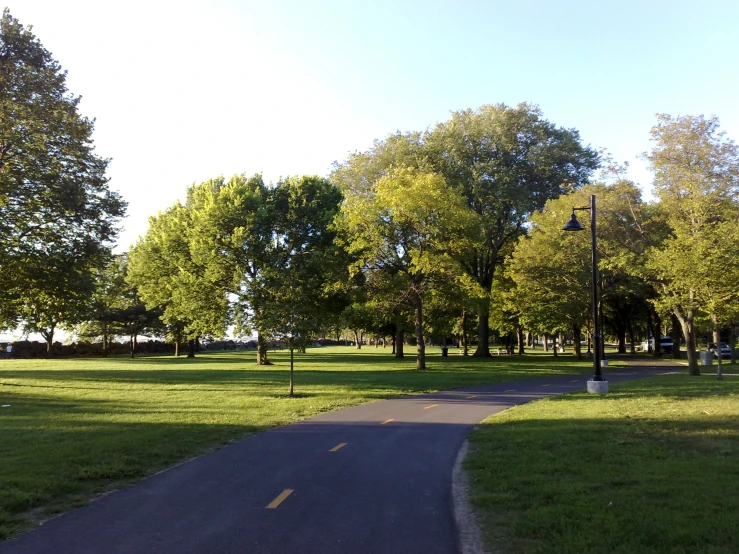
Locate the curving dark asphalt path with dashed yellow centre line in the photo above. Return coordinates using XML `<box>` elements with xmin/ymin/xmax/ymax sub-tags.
<box><xmin>0</xmin><ymin>367</ymin><xmax>674</xmax><ymax>554</ymax></box>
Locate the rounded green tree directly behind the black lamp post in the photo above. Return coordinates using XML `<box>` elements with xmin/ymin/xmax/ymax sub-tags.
<box><xmin>506</xmin><ymin>180</ymin><xmax>660</xmax><ymax>354</ymax></box>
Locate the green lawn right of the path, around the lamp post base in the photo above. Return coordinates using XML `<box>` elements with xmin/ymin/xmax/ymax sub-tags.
<box><xmin>465</xmin><ymin>365</ymin><xmax>739</xmax><ymax>553</ymax></box>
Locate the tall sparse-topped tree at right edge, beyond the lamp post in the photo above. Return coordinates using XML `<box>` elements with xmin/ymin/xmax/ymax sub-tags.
<box><xmin>645</xmin><ymin>114</ymin><xmax>739</xmax><ymax>375</ymax></box>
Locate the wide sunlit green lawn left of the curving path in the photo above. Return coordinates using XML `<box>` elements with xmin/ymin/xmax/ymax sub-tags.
<box><xmin>0</xmin><ymin>347</ymin><xmax>591</xmax><ymax>538</ymax></box>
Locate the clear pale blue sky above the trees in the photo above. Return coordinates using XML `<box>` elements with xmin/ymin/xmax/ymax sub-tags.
<box><xmin>7</xmin><ymin>0</ymin><xmax>739</xmax><ymax>249</ymax></box>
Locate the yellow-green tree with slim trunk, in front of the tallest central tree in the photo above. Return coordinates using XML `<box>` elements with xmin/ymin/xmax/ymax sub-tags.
<box><xmin>342</xmin><ymin>169</ymin><xmax>476</xmax><ymax>369</ymax></box>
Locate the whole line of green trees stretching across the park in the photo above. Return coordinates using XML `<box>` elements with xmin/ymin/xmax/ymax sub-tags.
<box><xmin>0</xmin><ymin>11</ymin><xmax>739</xmax><ymax>380</ymax></box>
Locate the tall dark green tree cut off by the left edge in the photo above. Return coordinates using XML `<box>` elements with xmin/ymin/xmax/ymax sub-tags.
<box><xmin>0</xmin><ymin>9</ymin><xmax>125</xmax><ymax>328</ymax></box>
